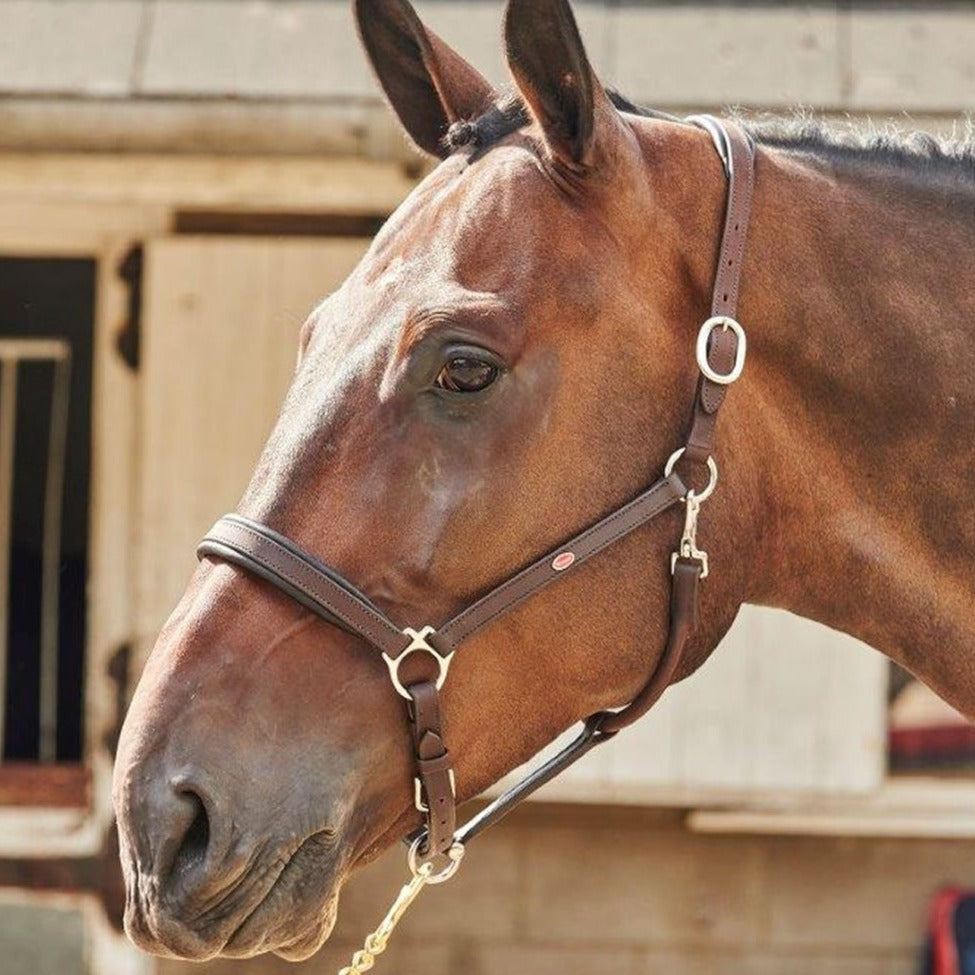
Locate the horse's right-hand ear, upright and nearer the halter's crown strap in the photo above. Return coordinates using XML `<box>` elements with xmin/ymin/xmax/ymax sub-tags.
<box><xmin>504</xmin><ymin>0</ymin><xmax>616</xmax><ymax>169</ymax></box>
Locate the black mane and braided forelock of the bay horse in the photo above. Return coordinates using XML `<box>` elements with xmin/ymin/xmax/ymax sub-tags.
<box><xmin>444</xmin><ymin>89</ymin><xmax>975</xmax><ymax>196</ymax></box>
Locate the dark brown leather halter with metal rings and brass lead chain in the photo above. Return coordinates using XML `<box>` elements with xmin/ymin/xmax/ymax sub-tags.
<box><xmin>197</xmin><ymin>115</ymin><xmax>754</xmax><ymax>975</ymax></box>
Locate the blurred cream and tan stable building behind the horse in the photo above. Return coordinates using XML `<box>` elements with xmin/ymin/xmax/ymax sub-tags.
<box><xmin>0</xmin><ymin>0</ymin><xmax>975</xmax><ymax>975</ymax></box>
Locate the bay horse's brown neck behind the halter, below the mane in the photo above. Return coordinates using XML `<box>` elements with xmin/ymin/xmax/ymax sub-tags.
<box><xmin>736</xmin><ymin>143</ymin><xmax>975</xmax><ymax>714</ymax></box>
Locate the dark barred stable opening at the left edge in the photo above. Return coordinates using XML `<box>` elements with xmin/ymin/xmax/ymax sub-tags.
<box><xmin>0</xmin><ymin>257</ymin><xmax>96</xmax><ymax>762</ymax></box>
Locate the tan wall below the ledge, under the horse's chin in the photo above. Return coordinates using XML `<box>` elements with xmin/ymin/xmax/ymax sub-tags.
<box><xmin>152</xmin><ymin>806</ymin><xmax>975</xmax><ymax>975</ymax></box>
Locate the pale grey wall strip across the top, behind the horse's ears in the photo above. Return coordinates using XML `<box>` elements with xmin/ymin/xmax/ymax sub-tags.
<box><xmin>0</xmin><ymin>0</ymin><xmax>975</xmax><ymax>157</ymax></box>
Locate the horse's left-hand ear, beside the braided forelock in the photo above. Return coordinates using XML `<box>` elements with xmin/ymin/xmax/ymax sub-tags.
<box><xmin>353</xmin><ymin>0</ymin><xmax>494</xmax><ymax>159</ymax></box>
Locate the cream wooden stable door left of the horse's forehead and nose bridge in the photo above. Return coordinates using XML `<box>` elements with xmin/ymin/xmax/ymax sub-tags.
<box><xmin>137</xmin><ymin>236</ymin><xmax>369</xmax><ymax>654</ymax></box>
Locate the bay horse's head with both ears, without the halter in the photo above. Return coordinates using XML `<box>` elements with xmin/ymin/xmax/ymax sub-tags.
<box><xmin>115</xmin><ymin>0</ymin><xmax>756</xmax><ymax>959</ymax></box>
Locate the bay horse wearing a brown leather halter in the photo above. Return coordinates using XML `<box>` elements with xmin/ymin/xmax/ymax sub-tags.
<box><xmin>114</xmin><ymin>0</ymin><xmax>975</xmax><ymax>971</ymax></box>
